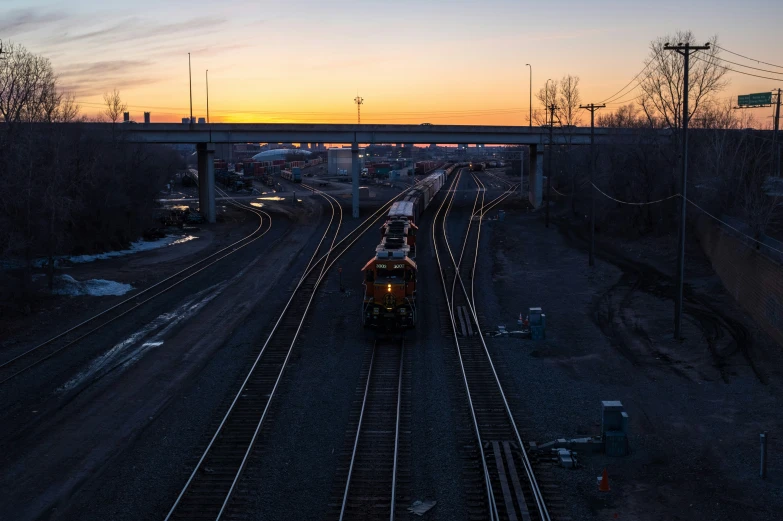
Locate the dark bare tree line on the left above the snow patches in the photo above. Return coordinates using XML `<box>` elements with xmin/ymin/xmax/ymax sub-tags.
<box><xmin>0</xmin><ymin>45</ymin><xmax>181</xmax><ymax>305</ymax></box>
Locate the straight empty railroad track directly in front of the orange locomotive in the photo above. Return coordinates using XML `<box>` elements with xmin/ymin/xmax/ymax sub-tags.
<box><xmin>331</xmin><ymin>340</ymin><xmax>410</xmax><ymax>521</ymax></box>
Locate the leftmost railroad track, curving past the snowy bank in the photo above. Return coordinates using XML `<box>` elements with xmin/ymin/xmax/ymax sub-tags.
<box><xmin>0</xmin><ymin>193</ymin><xmax>272</xmax><ymax>385</ymax></box>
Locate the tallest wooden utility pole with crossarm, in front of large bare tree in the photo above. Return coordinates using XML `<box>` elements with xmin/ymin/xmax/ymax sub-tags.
<box><xmin>663</xmin><ymin>42</ymin><xmax>710</xmax><ymax>340</ymax></box>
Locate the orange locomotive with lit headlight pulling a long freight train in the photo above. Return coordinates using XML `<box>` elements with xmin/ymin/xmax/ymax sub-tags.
<box><xmin>362</xmin><ymin>165</ymin><xmax>456</xmax><ymax>333</ymax></box>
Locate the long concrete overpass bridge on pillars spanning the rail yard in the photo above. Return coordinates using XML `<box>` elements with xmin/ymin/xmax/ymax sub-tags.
<box><xmin>104</xmin><ymin>123</ymin><xmax>671</xmax><ymax>222</ymax></box>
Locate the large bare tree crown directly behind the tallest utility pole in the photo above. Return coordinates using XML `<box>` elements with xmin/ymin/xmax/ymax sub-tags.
<box><xmin>639</xmin><ymin>31</ymin><xmax>729</xmax><ymax>128</ymax></box>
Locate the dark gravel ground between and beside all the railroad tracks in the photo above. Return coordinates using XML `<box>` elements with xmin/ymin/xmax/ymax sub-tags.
<box><xmin>0</xmin><ymin>169</ymin><xmax>783</xmax><ymax>520</ymax></box>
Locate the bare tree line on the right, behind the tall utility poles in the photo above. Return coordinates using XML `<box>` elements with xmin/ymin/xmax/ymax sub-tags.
<box><xmin>534</xmin><ymin>32</ymin><xmax>778</xmax><ymax>243</ymax></box>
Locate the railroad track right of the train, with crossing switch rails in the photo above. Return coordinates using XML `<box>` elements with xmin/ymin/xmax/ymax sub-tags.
<box><xmin>432</xmin><ymin>171</ymin><xmax>551</xmax><ymax>521</ymax></box>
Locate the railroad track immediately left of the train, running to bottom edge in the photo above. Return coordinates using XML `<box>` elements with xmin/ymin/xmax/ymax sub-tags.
<box><xmin>166</xmin><ymin>181</ymin><xmax>426</xmax><ymax>521</ymax></box>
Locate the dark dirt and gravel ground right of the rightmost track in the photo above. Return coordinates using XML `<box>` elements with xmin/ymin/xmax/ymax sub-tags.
<box><xmin>480</xmin><ymin>193</ymin><xmax>783</xmax><ymax>521</ymax></box>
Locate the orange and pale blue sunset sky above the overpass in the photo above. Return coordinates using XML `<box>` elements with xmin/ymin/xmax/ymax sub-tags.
<box><xmin>0</xmin><ymin>0</ymin><xmax>783</xmax><ymax>125</ymax></box>
